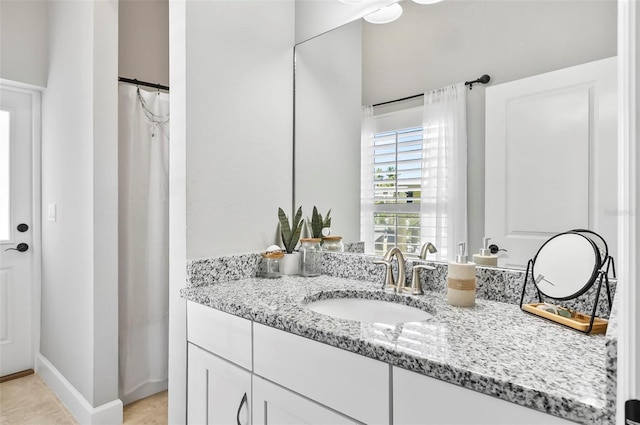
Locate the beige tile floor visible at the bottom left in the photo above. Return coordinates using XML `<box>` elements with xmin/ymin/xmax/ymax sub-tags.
<box><xmin>0</xmin><ymin>375</ymin><xmax>167</xmax><ymax>425</ymax></box>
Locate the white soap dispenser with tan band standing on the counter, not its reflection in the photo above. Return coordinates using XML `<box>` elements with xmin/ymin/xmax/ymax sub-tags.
<box><xmin>447</xmin><ymin>242</ymin><xmax>476</xmax><ymax>307</ymax></box>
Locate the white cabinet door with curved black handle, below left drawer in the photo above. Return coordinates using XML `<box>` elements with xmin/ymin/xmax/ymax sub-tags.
<box><xmin>187</xmin><ymin>344</ymin><xmax>251</xmax><ymax>425</ymax></box>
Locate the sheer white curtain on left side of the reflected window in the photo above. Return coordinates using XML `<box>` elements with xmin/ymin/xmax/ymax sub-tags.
<box><xmin>360</xmin><ymin>106</ymin><xmax>375</xmax><ymax>252</ymax></box>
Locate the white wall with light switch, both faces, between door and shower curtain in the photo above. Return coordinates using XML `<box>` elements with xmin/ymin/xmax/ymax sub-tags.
<box><xmin>41</xmin><ymin>0</ymin><xmax>122</xmax><ymax>420</ymax></box>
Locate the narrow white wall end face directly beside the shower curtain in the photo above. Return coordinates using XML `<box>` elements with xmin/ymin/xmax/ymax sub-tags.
<box><xmin>92</xmin><ymin>0</ymin><xmax>118</xmax><ymax>406</ymax></box>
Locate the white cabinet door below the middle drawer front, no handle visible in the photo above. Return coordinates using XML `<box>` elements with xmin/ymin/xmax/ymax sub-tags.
<box><xmin>252</xmin><ymin>375</ymin><xmax>360</xmax><ymax>425</ymax></box>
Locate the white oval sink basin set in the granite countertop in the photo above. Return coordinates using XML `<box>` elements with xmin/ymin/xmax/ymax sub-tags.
<box><xmin>307</xmin><ymin>298</ymin><xmax>433</xmax><ymax>324</ymax></box>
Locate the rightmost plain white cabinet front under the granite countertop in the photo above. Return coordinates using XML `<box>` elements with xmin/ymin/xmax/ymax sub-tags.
<box><xmin>393</xmin><ymin>367</ymin><xmax>573</xmax><ymax>425</ymax></box>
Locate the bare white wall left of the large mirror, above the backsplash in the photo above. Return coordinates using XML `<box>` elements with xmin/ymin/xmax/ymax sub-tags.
<box><xmin>186</xmin><ymin>0</ymin><xmax>294</xmax><ymax>258</ymax></box>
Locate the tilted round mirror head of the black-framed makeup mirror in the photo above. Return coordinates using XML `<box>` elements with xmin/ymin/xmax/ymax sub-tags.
<box><xmin>531</xmin><ymin>231</ymin><xmax>606</xmax><ymax>300</ymax></box>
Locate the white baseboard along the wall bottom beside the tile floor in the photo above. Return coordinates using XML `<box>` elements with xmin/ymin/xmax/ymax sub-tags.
<box><xmin>35</xmin><ymin>353</ymin><xmax>122</xmax><ymax>425</ymax></box>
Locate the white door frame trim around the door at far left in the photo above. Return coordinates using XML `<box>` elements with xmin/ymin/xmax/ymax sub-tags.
<box><xmin>0</xmin><ymin>78</ymin><xmax>44</xmax><ymax>370</ymax></box>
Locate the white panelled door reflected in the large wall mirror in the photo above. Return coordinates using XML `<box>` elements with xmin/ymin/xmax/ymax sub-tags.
<box><xmin>485</xmin><ymin>57</ymin><xmax>617</xmax><ymax>268</ymax></box>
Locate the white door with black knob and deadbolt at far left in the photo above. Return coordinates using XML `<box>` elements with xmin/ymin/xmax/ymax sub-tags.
<box><xmin>0</xmin><ymin>86</ymin><xmax>39</xmax><ymax>376</ymax></box>
